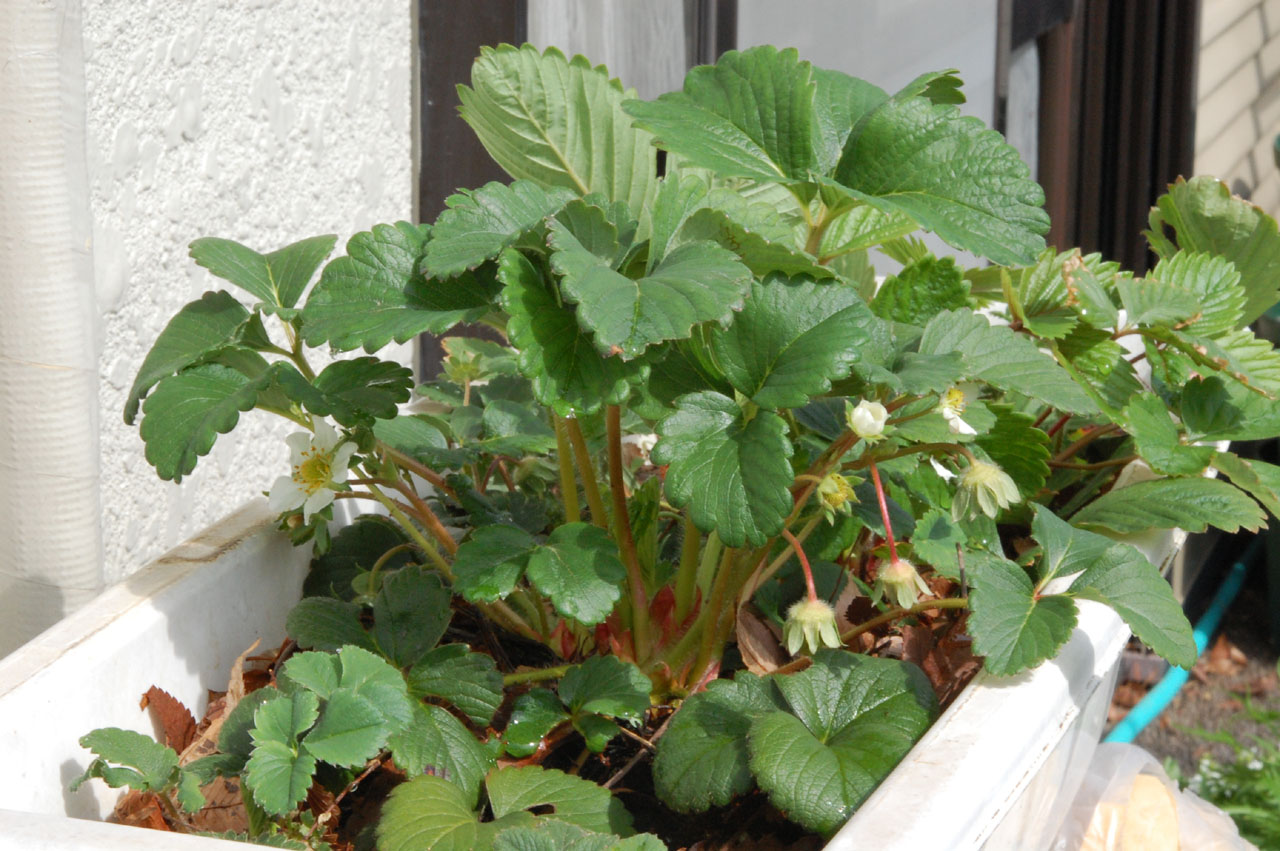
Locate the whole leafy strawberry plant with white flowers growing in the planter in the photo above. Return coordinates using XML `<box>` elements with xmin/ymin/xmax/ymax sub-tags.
<box><xmin>88</xmin><ymin>45</ymin><xmax>1280</xmax><ymax>850</ymax></box>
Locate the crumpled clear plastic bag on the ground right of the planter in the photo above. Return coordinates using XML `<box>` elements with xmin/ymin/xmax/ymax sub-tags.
<box><xmin>1050</xmin><ymin>742</ymin><xmax>1257</xmax><ymax>851</ymax></box>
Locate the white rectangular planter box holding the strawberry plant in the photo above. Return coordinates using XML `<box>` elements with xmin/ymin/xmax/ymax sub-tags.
<box><xmin>0</xmin><ymin>500</ymin><xmax>1185</xmax><ymax>851</ymax></box>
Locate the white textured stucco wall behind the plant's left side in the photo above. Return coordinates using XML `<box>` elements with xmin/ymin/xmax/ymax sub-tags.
<box><xmin>83</xmin><ymin>0</ymin><xmax>412</xmax><ymax>582</ymax></box>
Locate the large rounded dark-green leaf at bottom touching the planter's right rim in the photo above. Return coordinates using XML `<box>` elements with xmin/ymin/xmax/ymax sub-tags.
<box><xmin>748</xmin><ymin>650</ymin><xmax>938</xmax><ymax>836</ymax></box>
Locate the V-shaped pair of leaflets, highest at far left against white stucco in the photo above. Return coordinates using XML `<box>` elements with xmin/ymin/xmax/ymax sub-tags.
<box><xmin>191</xmin><ymin>234</ymin><xmax>338</xmax><ymax>312</ymax></box>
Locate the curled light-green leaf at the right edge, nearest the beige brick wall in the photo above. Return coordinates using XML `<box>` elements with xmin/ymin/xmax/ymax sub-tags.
<box><xmin>1144</xmin><ymin>177</ymin><xmax>1280</xmax><ymax>328</ymax></box>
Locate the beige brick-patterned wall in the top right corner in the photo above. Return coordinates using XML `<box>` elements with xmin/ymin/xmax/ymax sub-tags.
<box><xmin>1196</xmin><ymin>0</ymin><xmax>1280</xmax><ymax>216</ymax></box>
